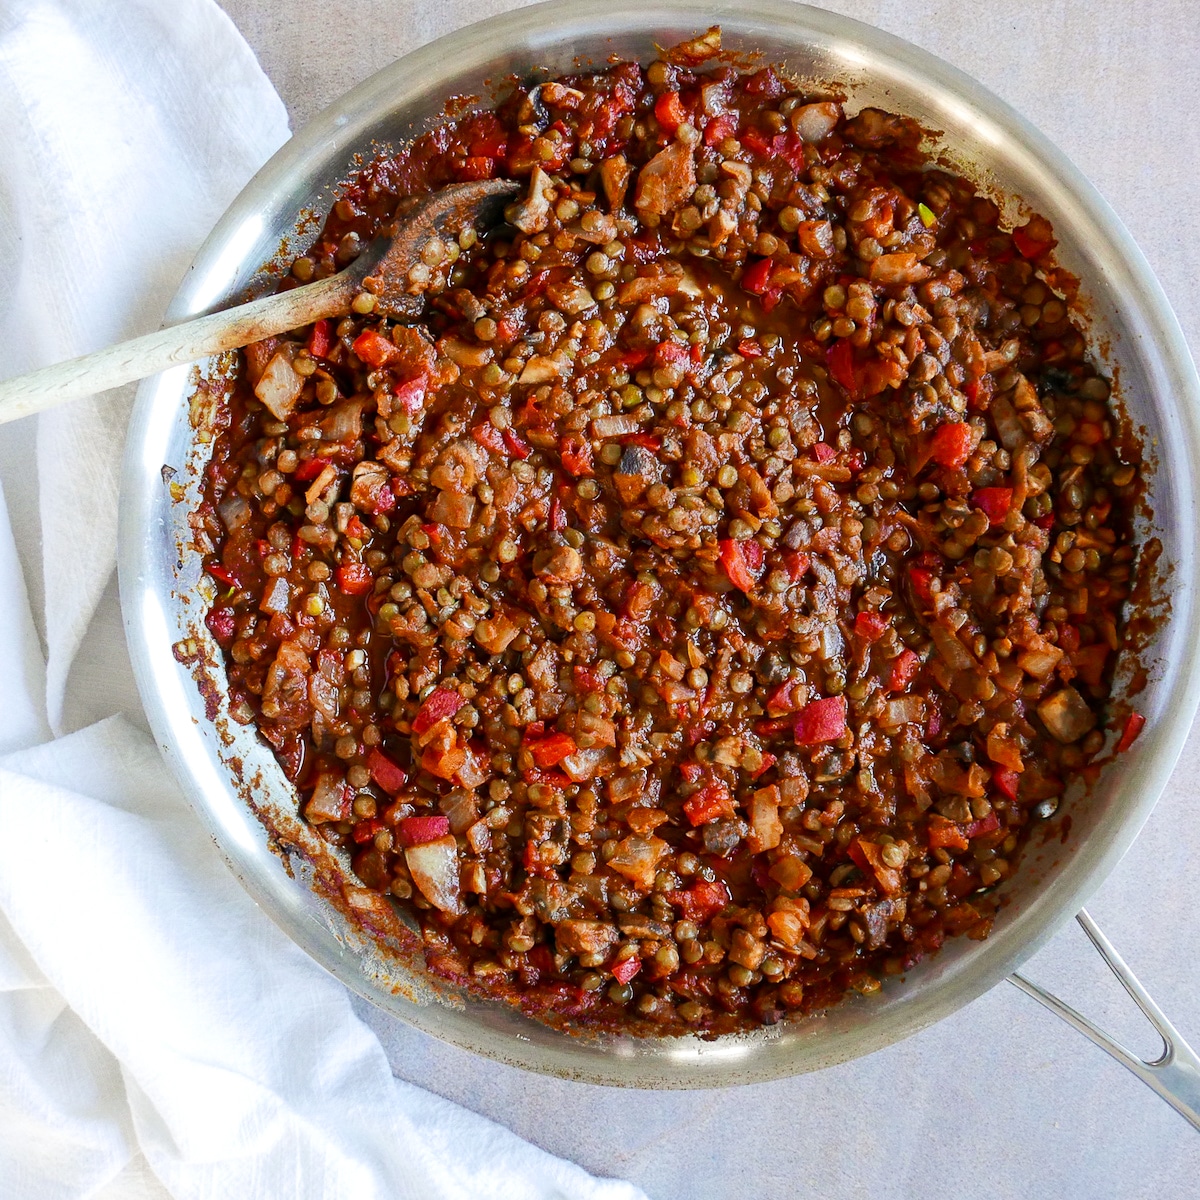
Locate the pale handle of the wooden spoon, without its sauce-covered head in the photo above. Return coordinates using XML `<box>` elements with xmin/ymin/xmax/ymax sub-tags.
<box><xmin>0</xmin><ymin>271</ymin><xmax>362</xmax><ymax>425</ymax></box>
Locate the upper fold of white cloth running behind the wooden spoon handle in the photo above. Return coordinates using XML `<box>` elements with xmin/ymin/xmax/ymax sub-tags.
<box><xmin>0</xmin><ymin>0</ymin><xmax>288</xmax><ymax>733</ymax></box>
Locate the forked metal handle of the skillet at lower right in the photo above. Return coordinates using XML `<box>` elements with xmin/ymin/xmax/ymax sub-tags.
<box><xmin>1008</xmin><ymin>910</ymin><xmax>1200</xmax><ymax>1129</ymax></box>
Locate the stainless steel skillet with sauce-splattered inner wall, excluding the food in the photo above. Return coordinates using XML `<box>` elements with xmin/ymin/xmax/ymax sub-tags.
<box><xmin>120</xmin><ymin>0</ymin><xmax>1200</xmax><ymax>1123</ymax></box>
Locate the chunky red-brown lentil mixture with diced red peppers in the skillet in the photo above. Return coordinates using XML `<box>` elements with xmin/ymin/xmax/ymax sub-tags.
<box><xmin>200</xmin><ymin>31</ymin><xmax>1140</xmax><ymax>1034</ymax></box>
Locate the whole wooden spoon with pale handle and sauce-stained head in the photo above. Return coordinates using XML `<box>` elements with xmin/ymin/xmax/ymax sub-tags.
<box><xmin>0</xmin><ymin>179</ymin><xmax>517</xmax><ymax>424</ymax></box>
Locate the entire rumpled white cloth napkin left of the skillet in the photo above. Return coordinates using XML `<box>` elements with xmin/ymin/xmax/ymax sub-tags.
<box><xmin>0</xmin><ymin>0</ymin><xmax>641</xmax><ymax>1200</ymax></box>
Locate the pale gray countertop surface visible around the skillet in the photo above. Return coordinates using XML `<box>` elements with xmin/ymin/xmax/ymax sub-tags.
<box><xmin>221</xmin><ymin>0</ymin><xmax>1200</xmax><ymax>1200</ymax></box>
